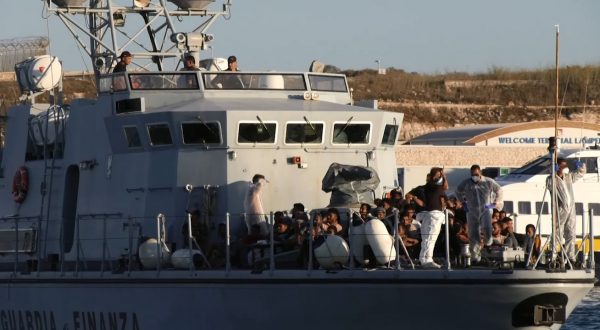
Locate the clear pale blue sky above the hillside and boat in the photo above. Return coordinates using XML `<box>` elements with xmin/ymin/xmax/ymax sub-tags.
<box><xmin>0</xmin><ymin>0</ymin><xmax>600</xmax><ymax>73</ymax></box>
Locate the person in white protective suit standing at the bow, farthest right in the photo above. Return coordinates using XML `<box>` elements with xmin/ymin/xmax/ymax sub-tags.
<box><xmin>546</xmin><ymin>158</ymin><xmax>586</xmax><ymax>264</ymax></box>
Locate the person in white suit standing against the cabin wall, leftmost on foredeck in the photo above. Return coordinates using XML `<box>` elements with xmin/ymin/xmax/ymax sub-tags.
<box><xmin>244</xmin><ymin>174</ymin><xmax>269</xmax><ymax>236</ymax></box>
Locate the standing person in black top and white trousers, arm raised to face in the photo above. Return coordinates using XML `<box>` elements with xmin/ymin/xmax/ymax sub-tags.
<box><xmin>417</xmin><ymin>167</ymin><xmax>448</xmax><ymax>268</ymax></box>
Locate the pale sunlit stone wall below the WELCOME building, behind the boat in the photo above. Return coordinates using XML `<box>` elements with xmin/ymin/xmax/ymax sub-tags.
<box><xmin>396</xmin><ymin>145</ymin><xmax>548</xmax><ymax>168</ymax></box>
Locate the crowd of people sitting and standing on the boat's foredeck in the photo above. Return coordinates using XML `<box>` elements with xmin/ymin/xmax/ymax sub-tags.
<box><xmin>186</xmin><ymin>162</ymin><xmax>581</xmax><ymax>268</ymax></box>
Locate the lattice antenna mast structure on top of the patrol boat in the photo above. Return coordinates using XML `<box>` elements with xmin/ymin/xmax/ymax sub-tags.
<box><xmin>44</xmin><ymin>0</ymin><xmax>231</xmax><ymax>76</ymax></box>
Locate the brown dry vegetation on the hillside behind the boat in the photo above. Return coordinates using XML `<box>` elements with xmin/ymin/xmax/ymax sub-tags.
<box><xmin>0</xmin><ymin>66</ymin><xmax>600</xmax><ymax>139</ymax></box>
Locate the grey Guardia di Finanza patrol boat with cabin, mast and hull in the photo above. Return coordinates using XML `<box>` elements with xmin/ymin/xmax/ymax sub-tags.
<box><xmin>0</xmin><ymin>0</ymin><xmax>594</xmax><ymax>329</ymax></box>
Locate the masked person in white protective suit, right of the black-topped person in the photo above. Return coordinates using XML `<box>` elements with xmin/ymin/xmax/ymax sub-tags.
<box><xmin>456</xmin><ymin>165</ymin><xmax>504</xmax><ymax>263</ymax></box>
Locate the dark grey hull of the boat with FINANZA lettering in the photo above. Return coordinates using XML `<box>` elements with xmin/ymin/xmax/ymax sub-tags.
<box><xmin>0</xmin><ymin>270</ymin><xmax>594</xmax><ymax>330</ymax></box>
